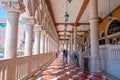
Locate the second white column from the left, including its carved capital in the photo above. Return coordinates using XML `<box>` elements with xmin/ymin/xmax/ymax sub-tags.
<box><xmin>24</xmin><ymin>16</ymin><xmax>34</xmax><ymax>56</ymax></box>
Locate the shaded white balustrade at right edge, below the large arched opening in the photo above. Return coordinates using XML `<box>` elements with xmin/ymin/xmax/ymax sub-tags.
<box><xmin>99</xmin><ymin>45</ymin><xmax>120</xmax><ymax>78</ymax></box>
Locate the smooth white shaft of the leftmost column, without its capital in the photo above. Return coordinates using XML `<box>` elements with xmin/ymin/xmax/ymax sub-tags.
<box><xmin>4</xmin><ymin>13</ymin><xmax>19</xmax><ymax>58</ymax></box>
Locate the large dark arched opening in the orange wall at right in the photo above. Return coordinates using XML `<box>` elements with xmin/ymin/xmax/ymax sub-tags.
<box><xmin>106</xmin><ymin>19</ymin><xmax>120</xmax><ymax>45</ymax></box>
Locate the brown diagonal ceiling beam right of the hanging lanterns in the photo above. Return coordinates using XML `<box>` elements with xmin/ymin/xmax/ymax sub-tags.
<box><xmin>75</xmin><ymin>0</ymin><xmax>89</xmax><ymax>26</ymax></box>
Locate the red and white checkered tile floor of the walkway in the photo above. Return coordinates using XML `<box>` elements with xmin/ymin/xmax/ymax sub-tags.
<box><xmin>36</xmin><ymin>55</ymin><xmax>110</xmax><ymax>80</ymax></box>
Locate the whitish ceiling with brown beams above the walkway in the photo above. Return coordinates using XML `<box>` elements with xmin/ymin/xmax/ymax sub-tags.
<box><xmin>46</xmin><ymin>0</ymin><xmax>120</xmax><ymax>39</ymax></box>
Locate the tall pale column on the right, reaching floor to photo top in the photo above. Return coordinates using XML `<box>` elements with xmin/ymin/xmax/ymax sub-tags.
<box><xmin>90</xmin><ymin>0</ymin><xmax>100</xmax><ymax>72</ymax></box>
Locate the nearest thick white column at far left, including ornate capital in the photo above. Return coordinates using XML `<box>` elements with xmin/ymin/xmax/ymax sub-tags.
<box><xmin>0</xmin><ymin>0</ymin><xmax>25</xmax><ymax>58</ymax></box>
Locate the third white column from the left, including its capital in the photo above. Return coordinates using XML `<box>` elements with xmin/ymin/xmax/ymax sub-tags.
<box><xmin>34</xmin><ymin>25</ymin><xmax>41</xmax><ymax>54</ymax></box>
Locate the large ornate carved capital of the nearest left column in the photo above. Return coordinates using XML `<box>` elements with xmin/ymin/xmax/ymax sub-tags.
<box><xmin>0</xmin><ymin>0</ymin><xmax>25</xmax><ymax>13</ymax></box>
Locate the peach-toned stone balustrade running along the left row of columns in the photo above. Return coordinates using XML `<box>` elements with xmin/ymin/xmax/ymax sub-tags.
<box><xmin>0</xmin><ymin>53</ymin><xmax>54</xmax><ymax>80</ymax></box>
